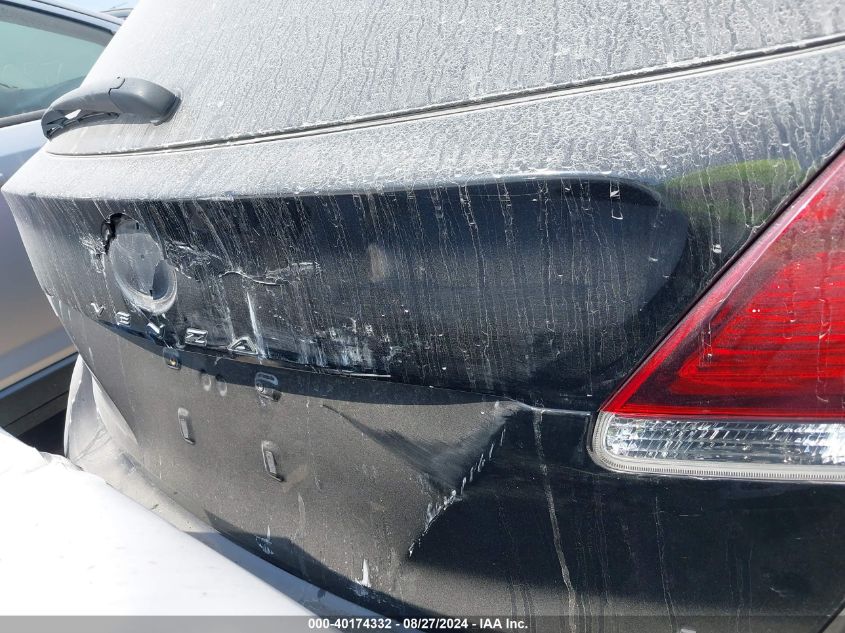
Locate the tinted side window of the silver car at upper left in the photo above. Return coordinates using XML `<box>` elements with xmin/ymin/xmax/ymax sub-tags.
<box><xmin>0</xmin><ymin>4</ymin><xmax>111</xmax><ymax>118</ymax></box>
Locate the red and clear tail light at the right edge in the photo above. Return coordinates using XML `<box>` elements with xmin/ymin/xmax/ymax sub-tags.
<box><xmin>592</xmin><ymin>154</ymin><xmax>845</xmax><ymax>481</ymax></box>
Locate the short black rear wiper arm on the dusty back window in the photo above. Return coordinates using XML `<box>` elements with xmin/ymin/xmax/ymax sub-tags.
<box><xmin>41</xmin><ymin>77</ymin><xmax>179</xmax><ymax>138</ymax></box>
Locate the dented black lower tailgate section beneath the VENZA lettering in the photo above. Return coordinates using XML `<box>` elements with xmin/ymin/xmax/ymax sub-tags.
<box><xmin>54</xmin><ymin>308</ymin><xmax>845</xmax><ymax>631</ymax></box>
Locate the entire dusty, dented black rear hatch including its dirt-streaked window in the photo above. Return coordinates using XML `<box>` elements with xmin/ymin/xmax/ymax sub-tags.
<box><xmin>4</xmin><ymin>1</ymin><xmax>845</xmax><ymax>631</ymax></box>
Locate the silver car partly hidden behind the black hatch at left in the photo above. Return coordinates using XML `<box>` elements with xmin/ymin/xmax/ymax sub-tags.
<box><xmin>0</xmin><ymin>0</ymin><xmax>121</xmax><ymax>435</ymax></box>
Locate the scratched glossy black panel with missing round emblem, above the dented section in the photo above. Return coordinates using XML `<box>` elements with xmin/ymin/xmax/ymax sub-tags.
<box><xmin>1</xmin><ymin>175</ymin><xmax>749</xmax><ymax>408</ymax></box>
